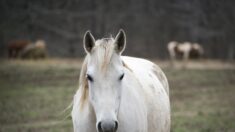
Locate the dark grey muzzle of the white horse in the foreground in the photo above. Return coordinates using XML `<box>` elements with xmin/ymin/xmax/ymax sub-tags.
<box><xmin>97</xmin><ymin>120</ymin><xmax>118</xmax><ymax>132</ymax></box>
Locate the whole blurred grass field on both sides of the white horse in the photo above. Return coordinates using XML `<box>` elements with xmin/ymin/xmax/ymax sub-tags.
<box><xmin>0</xmin><ymin>60</ymin><xmax>235</xmax><ymax>132</ymax></box>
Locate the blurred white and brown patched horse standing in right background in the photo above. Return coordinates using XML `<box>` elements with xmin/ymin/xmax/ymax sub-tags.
<box><xmin>167</xmin><ymin>41</ymin><xmax>204</xmax><ymax>66</ymax></box>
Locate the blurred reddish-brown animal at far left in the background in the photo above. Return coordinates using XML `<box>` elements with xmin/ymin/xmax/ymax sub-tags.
<box><xmin>7</xmin><ymin>40</ymin><xmax>31</xmax><ymax>58</ymax></box>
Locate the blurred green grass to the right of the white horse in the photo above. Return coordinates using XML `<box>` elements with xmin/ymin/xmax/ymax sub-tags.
<box><xmin>166</xmin><ymin>70</ymin><xmax>235</xmax><ymax>132</ymax></box>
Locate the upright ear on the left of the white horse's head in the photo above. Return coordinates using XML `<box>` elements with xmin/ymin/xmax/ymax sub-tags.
<box><xmin>83</xmin><ymin>31</ymin><xmax>95</xmax><ymax>53</ymax></box>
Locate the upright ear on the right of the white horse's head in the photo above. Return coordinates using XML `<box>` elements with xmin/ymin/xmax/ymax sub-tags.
<box><xmin>115</xmin><ymin>29</ymin><xmax>126</xmax><ymax>54</ymax></box>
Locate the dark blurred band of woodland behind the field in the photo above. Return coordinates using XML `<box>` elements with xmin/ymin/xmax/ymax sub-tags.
<box><xmin>0</xmin><ymin>0</ymin><xmax>235</xmax><ymax>59</ymax></box>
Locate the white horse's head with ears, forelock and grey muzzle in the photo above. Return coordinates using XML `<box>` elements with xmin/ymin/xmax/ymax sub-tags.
<box><xmin>83</xmin><ymin>30</ymin><xmax>126</xmax><ymax>132</ymax></box>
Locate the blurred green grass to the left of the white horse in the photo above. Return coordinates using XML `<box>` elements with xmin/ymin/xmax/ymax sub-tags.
<box><xmin>0</xmin><ymin>61</ymin><xmax>79</xmax><ymax>132</ymax></box>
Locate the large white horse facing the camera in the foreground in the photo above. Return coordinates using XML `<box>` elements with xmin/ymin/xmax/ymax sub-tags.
<box><xmin>72</xmin><ymin>30</ymin><xmax>170</xmax><ymax>132</ymax></box>
